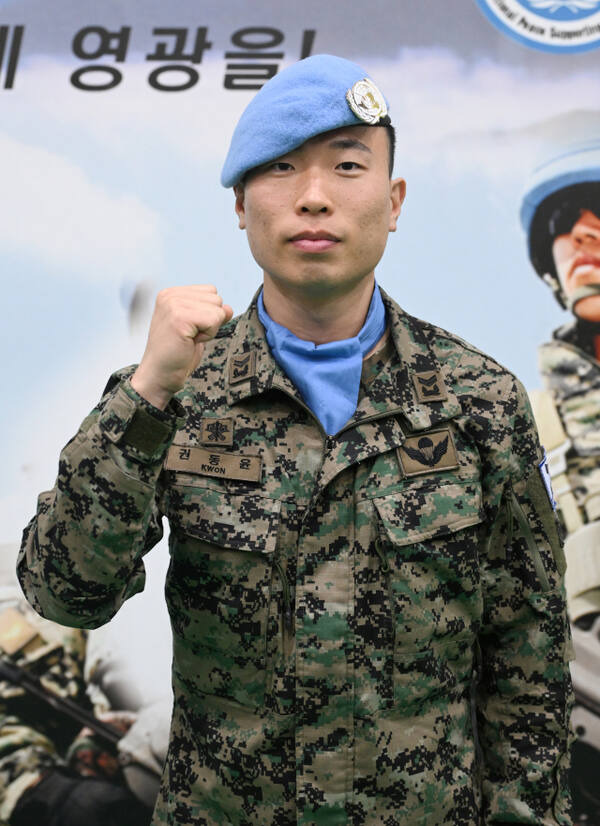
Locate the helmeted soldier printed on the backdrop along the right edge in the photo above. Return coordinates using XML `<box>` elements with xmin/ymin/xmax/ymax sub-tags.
<box><xmin>521</xmin><ymin>138</ymin><xmax>600</xmax><ymax>824</ymax></box>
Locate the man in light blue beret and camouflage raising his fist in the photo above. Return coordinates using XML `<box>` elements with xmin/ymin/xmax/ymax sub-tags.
<box><xmin>18</xmin><ymin>55</ymin><xmax>571</xmax><ymax>826</ymax></box>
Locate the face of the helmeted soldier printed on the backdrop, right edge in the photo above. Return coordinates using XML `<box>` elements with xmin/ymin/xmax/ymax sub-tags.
<box><xmin>552</xmin><ymin>210</ymin><xmax>600</xmax><ymax>322</ymax></box>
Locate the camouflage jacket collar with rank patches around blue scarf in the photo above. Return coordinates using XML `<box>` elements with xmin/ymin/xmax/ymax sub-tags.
<box><xmin>226</xmin><ymin>290</ymin><xmax>461</xmax><ymax>430</ymax></box>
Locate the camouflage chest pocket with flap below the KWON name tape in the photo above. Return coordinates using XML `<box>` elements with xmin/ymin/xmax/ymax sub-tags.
<box><xmin>166</xmin><ymin>486</ymin><xmax>280</xmax><ymax>707</ymax></box>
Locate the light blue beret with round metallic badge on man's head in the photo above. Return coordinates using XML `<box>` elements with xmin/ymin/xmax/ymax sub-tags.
<box><xmin>221</xmin><ymin>54</ymin><xmax>389</xmax><ymax>186</ymax></box>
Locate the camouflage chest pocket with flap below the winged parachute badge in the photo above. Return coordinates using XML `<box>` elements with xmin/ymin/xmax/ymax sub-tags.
<box><xmin>373</xmin><ymin>479</ymin><xmax>483</xmax><ymax>712</ymax></box>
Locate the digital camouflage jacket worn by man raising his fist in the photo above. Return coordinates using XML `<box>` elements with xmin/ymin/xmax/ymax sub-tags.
<box><xmin>19</xmin><ymin>296</ymin><xmax>571</xmax><ymax>826</ymax></box>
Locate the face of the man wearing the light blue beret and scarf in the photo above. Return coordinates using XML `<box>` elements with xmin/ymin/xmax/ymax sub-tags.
<box><xmin>235</xmin><ymin>126</ymin><xmax>405</xmax><ymax>297</ymax></box>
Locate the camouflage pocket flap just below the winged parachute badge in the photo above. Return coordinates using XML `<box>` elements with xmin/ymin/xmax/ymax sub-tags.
<box><xmin>373</xmin><ymin>479</ymin><xmax>483</xmax><ymax>545</ymax></box>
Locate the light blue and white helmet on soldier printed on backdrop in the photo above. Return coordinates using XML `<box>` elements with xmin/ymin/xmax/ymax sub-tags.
<box><xmin>520</xmin><ymin>138</ymin><xmax>600</xmax><ymax>234</ymax></box>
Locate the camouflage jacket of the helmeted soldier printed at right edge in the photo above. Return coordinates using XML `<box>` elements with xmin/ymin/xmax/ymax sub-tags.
<box><xmin>539</xmin><ymin>322</ymin><xmax>600</xmax><ymax>522</ymax></box>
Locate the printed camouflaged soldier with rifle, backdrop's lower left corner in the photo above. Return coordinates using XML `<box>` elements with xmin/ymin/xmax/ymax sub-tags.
<box><xmin>0</xmin><ymin>546</ymin><xmax>163</xmax><ymax>826</ymax></box>
